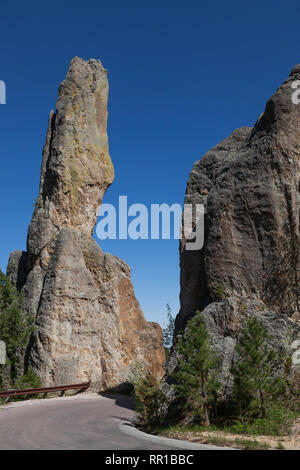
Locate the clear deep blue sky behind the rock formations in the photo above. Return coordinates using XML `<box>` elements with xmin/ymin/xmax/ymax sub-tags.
<box><xmin>0</xmin><ymin>0</ymin><xmax>300</xmax><ymax>322</ymax></box>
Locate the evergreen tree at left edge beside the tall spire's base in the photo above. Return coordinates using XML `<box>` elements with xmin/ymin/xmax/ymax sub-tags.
<box><xmin>0</xmin><ymin>271</ymin><xmax>34</xmax><ymax>385</ymax></box>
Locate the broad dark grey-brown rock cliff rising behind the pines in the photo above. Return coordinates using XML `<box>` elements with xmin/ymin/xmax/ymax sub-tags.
<box><xmin>172</xmin><ymin>65</ymin><xmax>300</xmax><ymax>390</ymax></box>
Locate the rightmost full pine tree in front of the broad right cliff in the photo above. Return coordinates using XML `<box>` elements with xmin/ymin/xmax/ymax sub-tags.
<box><xmin>231</xmin><ymin>317</ymin><xmax>276</xmax><ymax>417</ymax></box>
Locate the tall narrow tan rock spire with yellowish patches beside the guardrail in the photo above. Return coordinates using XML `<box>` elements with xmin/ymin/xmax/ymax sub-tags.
<box><xmin>7</xmin><ymin>57</ymin><xmax>164</xmax><ymax>389</ymax></box>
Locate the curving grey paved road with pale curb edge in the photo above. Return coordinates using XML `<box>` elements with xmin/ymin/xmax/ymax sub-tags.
<box><xmin>0</xmin><ymin>394</ymin><xmax>223</xmax><ymax>450</ymax></box>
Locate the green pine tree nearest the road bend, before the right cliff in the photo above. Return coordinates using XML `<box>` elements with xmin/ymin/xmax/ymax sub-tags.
<box><xmin>174</xmin><ymin>312</ymin><xmax>220</xmax><ymax>426</ymax></box>
